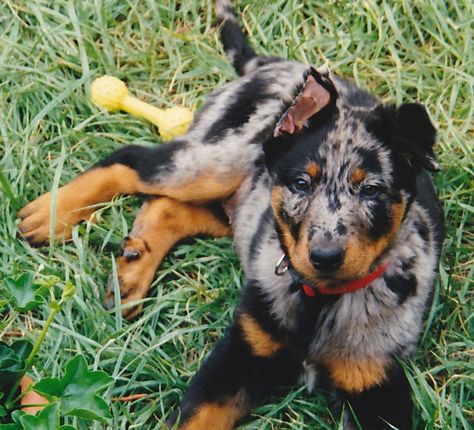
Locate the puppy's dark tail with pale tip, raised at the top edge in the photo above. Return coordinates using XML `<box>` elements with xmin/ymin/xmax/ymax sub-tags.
<box><xmin>216</xmin><ymin>0</ymin><xmax>281</xmax><ymax>76</ymax></box>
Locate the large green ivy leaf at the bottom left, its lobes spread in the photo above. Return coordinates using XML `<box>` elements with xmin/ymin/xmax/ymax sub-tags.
<box><xmin>33</xmin><ymin>355</ymin><xmax>113</xmax><ymax>421</ymax></box>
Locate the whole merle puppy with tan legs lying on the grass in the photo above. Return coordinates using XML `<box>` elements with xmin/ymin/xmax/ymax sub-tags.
<box><xmin>20</xmin><ymin>1</ymin><xmax>443</xmax><ymax>430</ymax></box>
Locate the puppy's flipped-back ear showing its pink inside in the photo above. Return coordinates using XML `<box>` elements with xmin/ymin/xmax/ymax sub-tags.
<box><xmin>273</xmin><ymin>65</ymin><xmax>337</xmax><ymax>137</ymax></box>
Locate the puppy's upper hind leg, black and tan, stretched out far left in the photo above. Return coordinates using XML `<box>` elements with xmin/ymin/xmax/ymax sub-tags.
<box><xmin>18</xmin><ymin>142</ymin><xmax>245</xmax><ymax>245</ymax></box>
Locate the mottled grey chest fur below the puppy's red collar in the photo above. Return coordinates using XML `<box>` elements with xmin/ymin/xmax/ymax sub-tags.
<box><xmin>308</xmin><ymin>206</ymin><xmax>437</xmax><ymax>361</ymax></box>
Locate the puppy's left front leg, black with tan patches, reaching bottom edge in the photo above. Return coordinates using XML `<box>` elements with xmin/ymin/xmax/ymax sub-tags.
<box><xmin>172</xmin><ymin>310</ymin><xmax>301</xmax><ymax>430</ymax></box>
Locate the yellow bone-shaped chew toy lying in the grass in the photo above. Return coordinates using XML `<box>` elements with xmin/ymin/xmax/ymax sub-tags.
<box><xmin>91</xmin><ymin>75</ymin><xmax>193</xmax><ymax>140</ymax></box>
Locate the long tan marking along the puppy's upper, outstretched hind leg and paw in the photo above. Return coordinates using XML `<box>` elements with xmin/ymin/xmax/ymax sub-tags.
<box><xmin>18</xmin><ymin>164</ymin><xmax>243</xmax><ymax>243</ymax></box>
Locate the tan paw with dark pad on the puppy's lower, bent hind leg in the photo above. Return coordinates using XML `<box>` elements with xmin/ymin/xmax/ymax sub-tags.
<box><xmin>105</xmin><ymin>237</ymin><xmax>156</xmax><ymax>320</ymax></box>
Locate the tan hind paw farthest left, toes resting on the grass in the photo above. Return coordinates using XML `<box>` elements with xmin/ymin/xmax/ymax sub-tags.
<box><xmin>18</xmin><ymin>190</ymin><xmax>93</xmax><ymax>246</ymax></box>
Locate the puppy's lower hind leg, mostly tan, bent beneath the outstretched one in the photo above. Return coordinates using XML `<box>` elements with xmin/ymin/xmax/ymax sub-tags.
<box><xmin>106</xmin><ymin>197</ymin><xmax>231</xmax><ymax>318</ymax></box>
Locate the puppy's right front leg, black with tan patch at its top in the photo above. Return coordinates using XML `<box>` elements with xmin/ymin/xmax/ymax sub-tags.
<box><xmin>328</xmin><ymin>359</ymin><xmax>413</xmax><ymax>430</ymax></box>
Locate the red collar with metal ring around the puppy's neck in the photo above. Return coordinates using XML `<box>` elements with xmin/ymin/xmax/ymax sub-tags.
<box><xmin>275</xmin><ymin>256</ymin><xmax>390</xmax><ymax>297</ymax></box>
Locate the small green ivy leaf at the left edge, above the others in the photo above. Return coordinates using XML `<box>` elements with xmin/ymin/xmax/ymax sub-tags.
<box><xmin>4</xmin><ymin>273</ymin><xmax>46</xmax><ymax>312</ymax></box>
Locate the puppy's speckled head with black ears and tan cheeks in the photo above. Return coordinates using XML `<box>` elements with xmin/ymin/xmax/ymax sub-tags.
<box><xmin>265</xmin><ymin>69</ymin><xmax>436</xmax><ymax>285</ymax></box>
